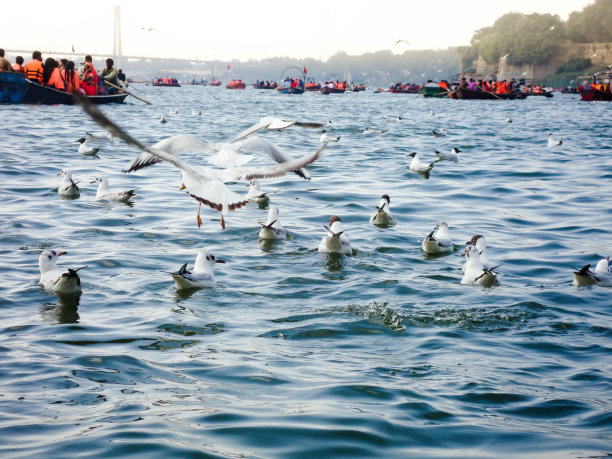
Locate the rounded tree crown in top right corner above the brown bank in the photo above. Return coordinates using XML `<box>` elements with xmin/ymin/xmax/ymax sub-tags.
<box><xmin>566</xmin><ymin>0</ymin><xmax>612</xmax><ymax>43</ymax></box>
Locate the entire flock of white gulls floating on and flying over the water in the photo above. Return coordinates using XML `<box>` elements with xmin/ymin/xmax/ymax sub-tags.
<box><xmin>39</xmin><ymin>99</ymin><xmax>612</xmax><ymax>295</ymax></box>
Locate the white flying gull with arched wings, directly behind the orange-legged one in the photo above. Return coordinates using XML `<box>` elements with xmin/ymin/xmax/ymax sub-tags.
<box><xmin>123</xmin><ymin>134</ymin><xmax>310</xmax><ymax>180</ymax></box>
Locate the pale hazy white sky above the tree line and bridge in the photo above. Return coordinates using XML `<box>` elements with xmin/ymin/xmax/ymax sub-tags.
<box><xmin>0</xmin><ymin>0</ymin><xmax>593</xmax><ymax>61</ymax></box>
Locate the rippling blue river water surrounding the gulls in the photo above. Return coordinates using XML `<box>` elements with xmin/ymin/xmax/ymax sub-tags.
<box><xmin>0</xmin><ymin>86</ymin><xmax>612</xmax><ymax>458</ymax></box>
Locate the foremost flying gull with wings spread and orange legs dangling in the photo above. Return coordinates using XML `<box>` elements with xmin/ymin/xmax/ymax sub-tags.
<box><xmin>75</xmin><ymin>96</ymin><xmax>327</xmax><ymax>228</ymax></box>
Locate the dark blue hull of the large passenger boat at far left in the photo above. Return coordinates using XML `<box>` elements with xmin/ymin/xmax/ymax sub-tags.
<box><xmin>0</xmin><ymin>72</ymin><xmax>128</xmax><ymax>105</ymax></box>
